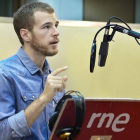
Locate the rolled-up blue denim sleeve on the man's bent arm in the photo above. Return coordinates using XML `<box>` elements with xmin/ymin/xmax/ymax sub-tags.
<box><xmin>0</xmin><ymin>70</ymin><xmax>31</xmax><ymax>140</ymax></box>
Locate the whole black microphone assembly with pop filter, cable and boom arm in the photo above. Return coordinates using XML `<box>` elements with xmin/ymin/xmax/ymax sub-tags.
<box><xmin>90</xmin><ymin>16</ymin><xmax>140</xmax><ymax>72</ymax></box>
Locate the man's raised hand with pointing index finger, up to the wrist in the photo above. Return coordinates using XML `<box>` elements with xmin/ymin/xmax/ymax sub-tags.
<box><xmin>42</xmin><ymin>66</ymin><xmax>68</xmax><ymax>102</ymax></box>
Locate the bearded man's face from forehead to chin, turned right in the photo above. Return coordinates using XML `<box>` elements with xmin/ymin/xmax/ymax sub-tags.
<box><xmin>31</xmin><ymin>11</ymin><xmax>59</xmax><ymax>56</ymax></box>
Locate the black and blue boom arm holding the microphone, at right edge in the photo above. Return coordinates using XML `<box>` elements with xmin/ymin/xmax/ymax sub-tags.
<box><xmin>112</xmin><ymin>26</ymin><xmax>140</xmax><ymax>39</ymax></box>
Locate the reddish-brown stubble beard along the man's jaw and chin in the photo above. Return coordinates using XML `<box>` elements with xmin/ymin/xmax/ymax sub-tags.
<box><xmin>31</xmin><ymin>33</ymin><xmax>58</xmax><ymax>57</ymax></box>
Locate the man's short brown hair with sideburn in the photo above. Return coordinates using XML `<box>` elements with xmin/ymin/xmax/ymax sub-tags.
<box><xmin>13</xmin><ymin>2</ymin><xmax>54</xmax><ymax>45</ymax></box>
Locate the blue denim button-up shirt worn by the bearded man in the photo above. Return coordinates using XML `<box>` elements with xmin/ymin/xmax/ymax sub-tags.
<box><xmin>0</xmin><ymin>48</ymin><xmax>64</xmax><ymax>140</ymax></box>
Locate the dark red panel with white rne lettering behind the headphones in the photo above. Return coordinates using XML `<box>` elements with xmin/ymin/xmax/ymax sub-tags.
<box><xmin>50</xmin><ymin>99</ymin><xmax>140</xmax><ymax>140</ymax></box>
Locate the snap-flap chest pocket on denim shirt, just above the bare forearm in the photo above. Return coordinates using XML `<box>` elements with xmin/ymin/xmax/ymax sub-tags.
<box><xmin>21</xmin><ymin>92</ymin><xmax>39</xmax><ymax>108</ymax></box>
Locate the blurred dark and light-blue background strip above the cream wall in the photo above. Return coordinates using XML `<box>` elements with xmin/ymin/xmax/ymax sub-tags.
<box><xmin>0</xmin><ymin>0</ymin><xmax>140</xmax><ymax>23</ymax></box>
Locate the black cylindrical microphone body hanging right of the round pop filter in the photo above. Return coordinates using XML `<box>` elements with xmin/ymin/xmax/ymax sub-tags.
<box><xmin>98</xmin><ymin>27</ymin><xmax>110</xmax><ymax>67</ymax></box>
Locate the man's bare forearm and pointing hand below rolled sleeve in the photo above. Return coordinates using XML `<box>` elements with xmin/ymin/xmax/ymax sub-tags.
<box><xmin>25</xmin><ymin>67</ymin><xmax>68</xmax><ymax>127</ymax></box>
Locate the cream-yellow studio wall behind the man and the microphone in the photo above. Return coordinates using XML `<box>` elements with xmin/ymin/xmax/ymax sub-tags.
<box><xmin>0</xmin><ymin>17</ymin><xmax>140</xmax><ymax>98</ymax></box>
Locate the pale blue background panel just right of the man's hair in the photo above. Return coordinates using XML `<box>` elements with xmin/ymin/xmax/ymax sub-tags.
<box><xmin>38</xmin><ymin>0</ymin><xmax>83</xmax><ymax>20</ymax></box>
